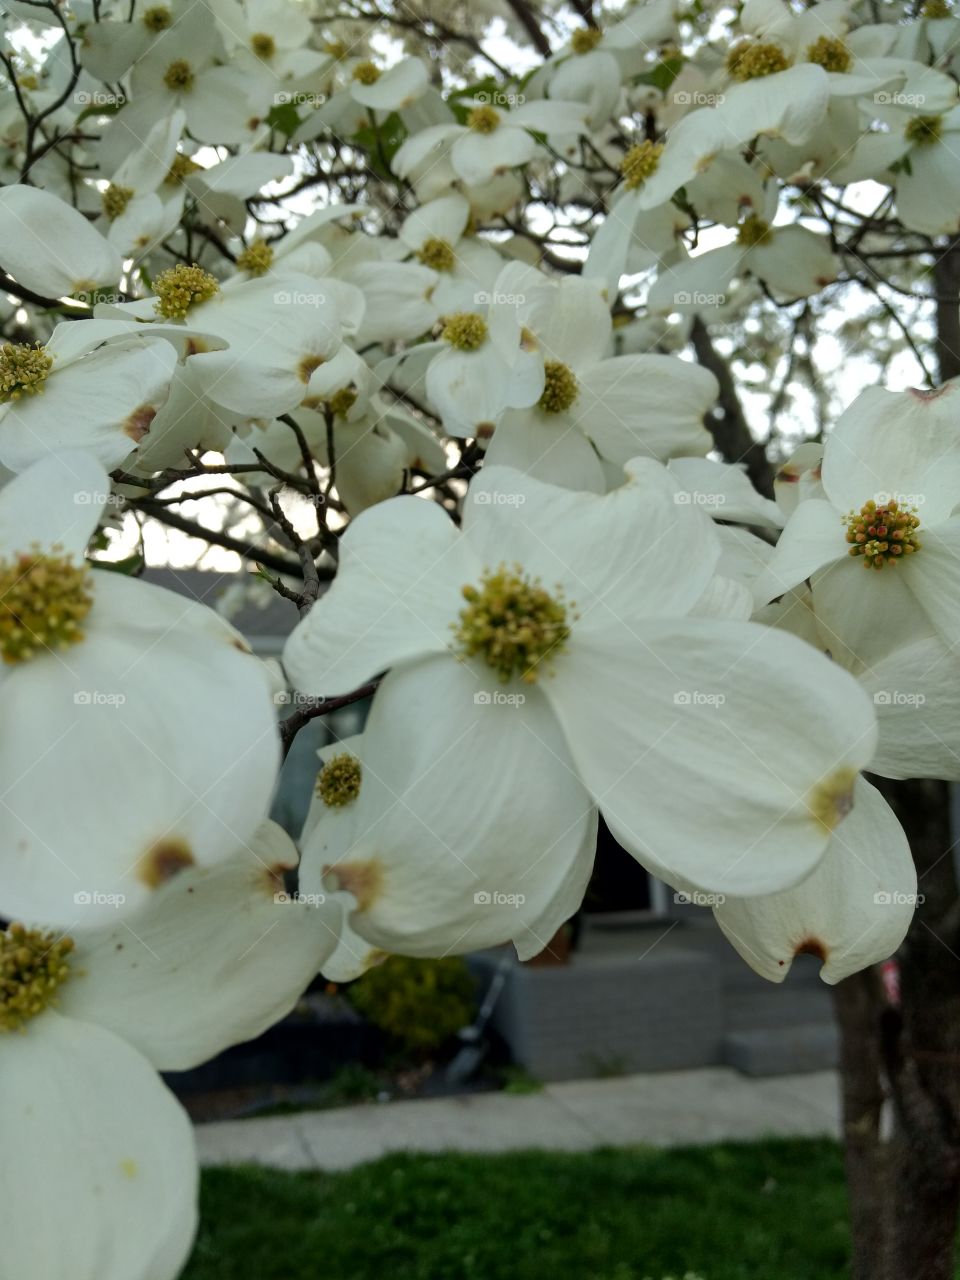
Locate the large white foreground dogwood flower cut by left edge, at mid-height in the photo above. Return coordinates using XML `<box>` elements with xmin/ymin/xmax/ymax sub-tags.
<box><xmin>0</xmin><ymin>451</ymin><xmax>278</xmax><ymax>925</ymax></box>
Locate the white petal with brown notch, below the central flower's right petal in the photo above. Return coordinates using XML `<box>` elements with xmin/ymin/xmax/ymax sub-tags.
<box><xmin>713</xmin><ymin>778</ymin><xmax>916</xmax><ymax>983</ymax></box>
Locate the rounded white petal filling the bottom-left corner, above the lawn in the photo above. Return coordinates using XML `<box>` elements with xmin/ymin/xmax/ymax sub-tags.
<box><xmin>0</xmin><ymin>1011</ymin><xmax>197</xmax><ymax>1280</ymax></box>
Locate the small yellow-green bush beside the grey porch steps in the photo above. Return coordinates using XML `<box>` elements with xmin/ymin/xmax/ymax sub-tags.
<box><xmin>347</xmin><ymin>956</ymin><xmax>476</xmax><ymax>1053</ymax></box>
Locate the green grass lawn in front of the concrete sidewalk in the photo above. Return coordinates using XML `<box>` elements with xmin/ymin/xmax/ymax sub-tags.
<box><xmin>183</xmin><ymin>1140</ymin><xmax>849</xmax><ymax>1280</ymax></box>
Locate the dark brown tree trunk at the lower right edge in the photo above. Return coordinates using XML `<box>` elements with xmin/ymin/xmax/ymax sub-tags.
<box><xmin>835</xmin><ymin>781</ymin><xmax>960</xmax><ymax>1280</ymax></box>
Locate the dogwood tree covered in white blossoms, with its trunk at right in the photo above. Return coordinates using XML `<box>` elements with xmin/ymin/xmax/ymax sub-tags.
<box><xmin>0</xmin><ymin>0</ymin><xmax>960</xmax><ymax>1280</ymax></box>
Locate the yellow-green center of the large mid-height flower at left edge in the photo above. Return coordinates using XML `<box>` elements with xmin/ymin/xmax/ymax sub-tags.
<box><xmin>0</xmin><ymin>547</ymin><xmax>93</xmax><ymax>663</ymax></box>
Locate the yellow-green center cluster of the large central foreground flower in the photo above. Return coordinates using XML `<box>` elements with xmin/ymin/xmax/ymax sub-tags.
<box><xmin>453</xmin><ymin>564</ymin><xmax>571</xmax><ymax>684</ymax></box>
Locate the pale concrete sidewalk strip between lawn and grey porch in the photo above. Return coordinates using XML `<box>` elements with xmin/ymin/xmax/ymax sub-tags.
<box><xmin>197</xmin><ymin>1066</ymin><xmax>840</xmax><ymax>1170</ymax></box>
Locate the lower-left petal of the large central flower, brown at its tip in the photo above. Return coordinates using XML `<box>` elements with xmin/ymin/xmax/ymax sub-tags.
<box><xmin>303</xmin><ymin>657</ymin><xmax>593</xmax><ymax>955</ymax></box>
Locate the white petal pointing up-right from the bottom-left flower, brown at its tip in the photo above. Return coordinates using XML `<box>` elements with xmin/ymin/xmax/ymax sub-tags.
<box><xmin>60</xmin><ymin>823</ymin><xmax>342</xmax><ymax>1071</ymax></box>
